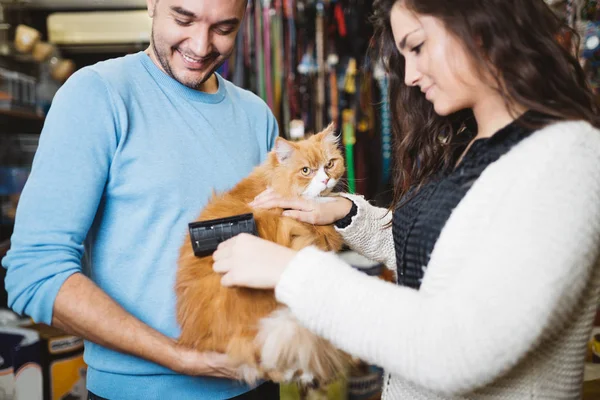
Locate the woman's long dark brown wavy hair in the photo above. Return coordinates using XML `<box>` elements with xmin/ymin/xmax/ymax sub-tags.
<box><xmin>372</xmin><ymin>0</ymin><xmax>600</xmax><ymax>208</ymax></box>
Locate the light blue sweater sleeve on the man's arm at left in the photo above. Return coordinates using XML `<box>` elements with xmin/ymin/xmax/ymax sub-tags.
<box><xmin>2</xmin><ymin>68</ymin><xmax>117</xmax><ymax>324</ymax></box>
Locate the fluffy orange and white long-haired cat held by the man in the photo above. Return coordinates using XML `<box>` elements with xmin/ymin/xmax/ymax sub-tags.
<box><xmin>175</xmin><ymin>124</ymin><xmax>349</xmax><ymax>384</ymax></box>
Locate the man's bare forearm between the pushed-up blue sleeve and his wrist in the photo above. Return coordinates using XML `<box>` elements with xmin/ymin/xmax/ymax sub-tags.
<box><xmin>52</xmin><ymin>273</ymin><xmax>178</xmax><ymax>370</ymax></box>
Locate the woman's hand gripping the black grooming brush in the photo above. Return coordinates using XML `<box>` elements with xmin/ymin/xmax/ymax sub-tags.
<box><xmin>213</xmin><ymin>233</ymin><xmax>296</xmax><ymax>289</ymax></box>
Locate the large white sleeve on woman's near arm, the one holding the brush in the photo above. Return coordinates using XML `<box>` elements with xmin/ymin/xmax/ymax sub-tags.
<box><xmin>276</xmin><ymin>128</ymin><xmax>600</xmax><ymax>395</ymax></box>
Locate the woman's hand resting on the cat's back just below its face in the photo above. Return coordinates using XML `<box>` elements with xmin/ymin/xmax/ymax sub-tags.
<box><xmin>250</xmin><ymin>189</ymin><xmax>352</xmax><ymax>225</ymax></box>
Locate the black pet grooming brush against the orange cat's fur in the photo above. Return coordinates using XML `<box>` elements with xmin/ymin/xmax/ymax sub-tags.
<box><xmin>188</xmin><ymin>214</ymin><xmax>258</xmax><ymax>257</ymax></box>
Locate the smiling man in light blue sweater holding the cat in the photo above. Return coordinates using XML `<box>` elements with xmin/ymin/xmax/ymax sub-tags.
<box><xmin>3</xmin><ymin>0</ymin><xmax>278</xmax><ymax>400</ymax></box>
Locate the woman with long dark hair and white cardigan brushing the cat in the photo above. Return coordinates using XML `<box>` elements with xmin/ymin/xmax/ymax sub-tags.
<box><xmin>214</xmin><ymin>0</ymin><xmax>600</xmax><ymax>399</ymax></box>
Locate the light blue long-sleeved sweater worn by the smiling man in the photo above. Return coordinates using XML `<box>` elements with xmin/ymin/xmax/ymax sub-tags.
<box><xmin>3</xmin><ymin>52</ymin><xmax>277</xmax><ymax>400</ymax></box>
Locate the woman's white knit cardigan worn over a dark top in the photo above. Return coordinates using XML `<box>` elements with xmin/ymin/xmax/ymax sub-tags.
<box><xmin>276</xmin><ymin>122</ymin><xmax>600</xmax><ymax>400</ymax></box>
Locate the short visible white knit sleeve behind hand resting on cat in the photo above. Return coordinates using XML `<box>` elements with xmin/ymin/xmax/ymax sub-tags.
<box><xmin>336</xmin><ymin>193</ymin><xmax>396</xmax><ymax>269</ymax></box>
